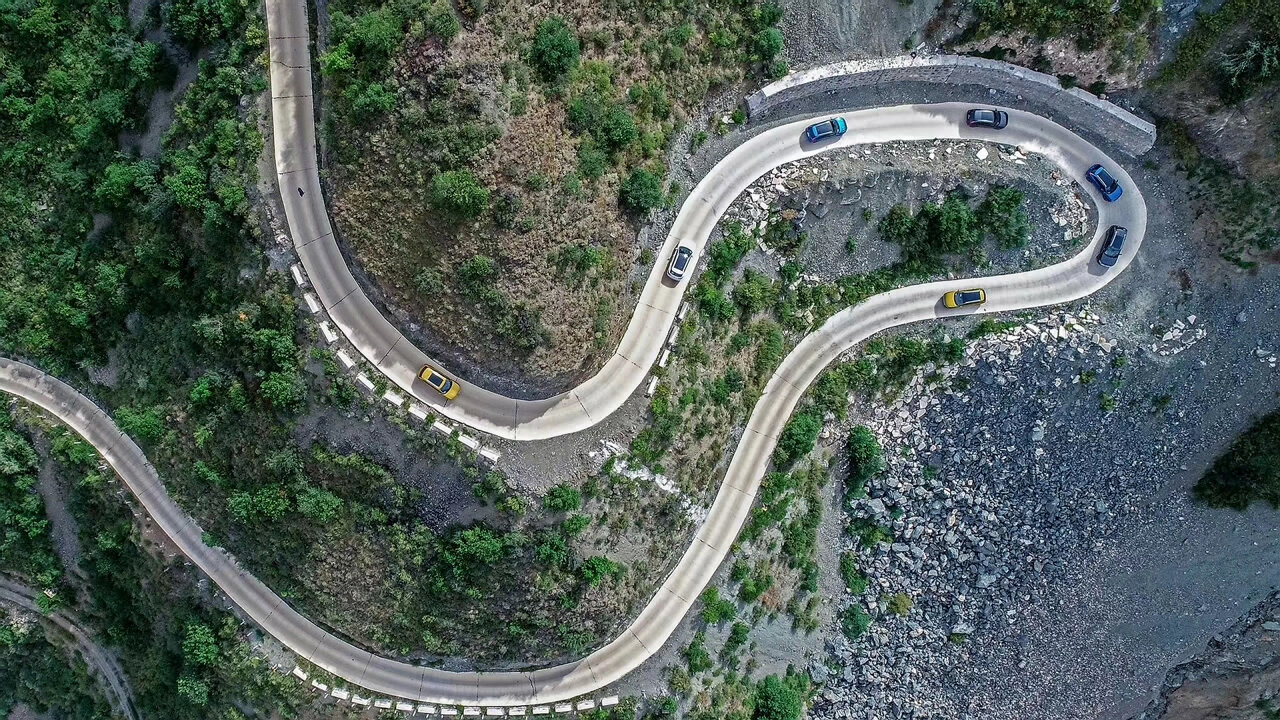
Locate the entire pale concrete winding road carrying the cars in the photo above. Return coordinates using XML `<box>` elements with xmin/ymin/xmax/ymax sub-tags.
<box><xmin>0</xmin><ymin>0</ymin><xmax>1147</xmax><ymax>707</ymax></box>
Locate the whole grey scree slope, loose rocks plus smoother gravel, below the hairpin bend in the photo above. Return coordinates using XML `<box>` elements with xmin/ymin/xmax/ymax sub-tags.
<box><xmin>810</xmin><ymin>293</ymin><xmax>1280</xmax><ymax>720</ymax></box>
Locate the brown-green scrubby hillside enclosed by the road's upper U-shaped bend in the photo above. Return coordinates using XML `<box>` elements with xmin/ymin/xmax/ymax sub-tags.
<box><xmin>321</xmin><ymin>0</ymin><xmax>785</xmax><ymax>380</ymax></box>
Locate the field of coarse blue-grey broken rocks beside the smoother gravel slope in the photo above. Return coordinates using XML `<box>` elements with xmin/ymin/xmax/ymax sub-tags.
<box><xmin>813</xmin><ymin>310</ymin><xmax>1146</xmax><ymax>720</ymax></box>
